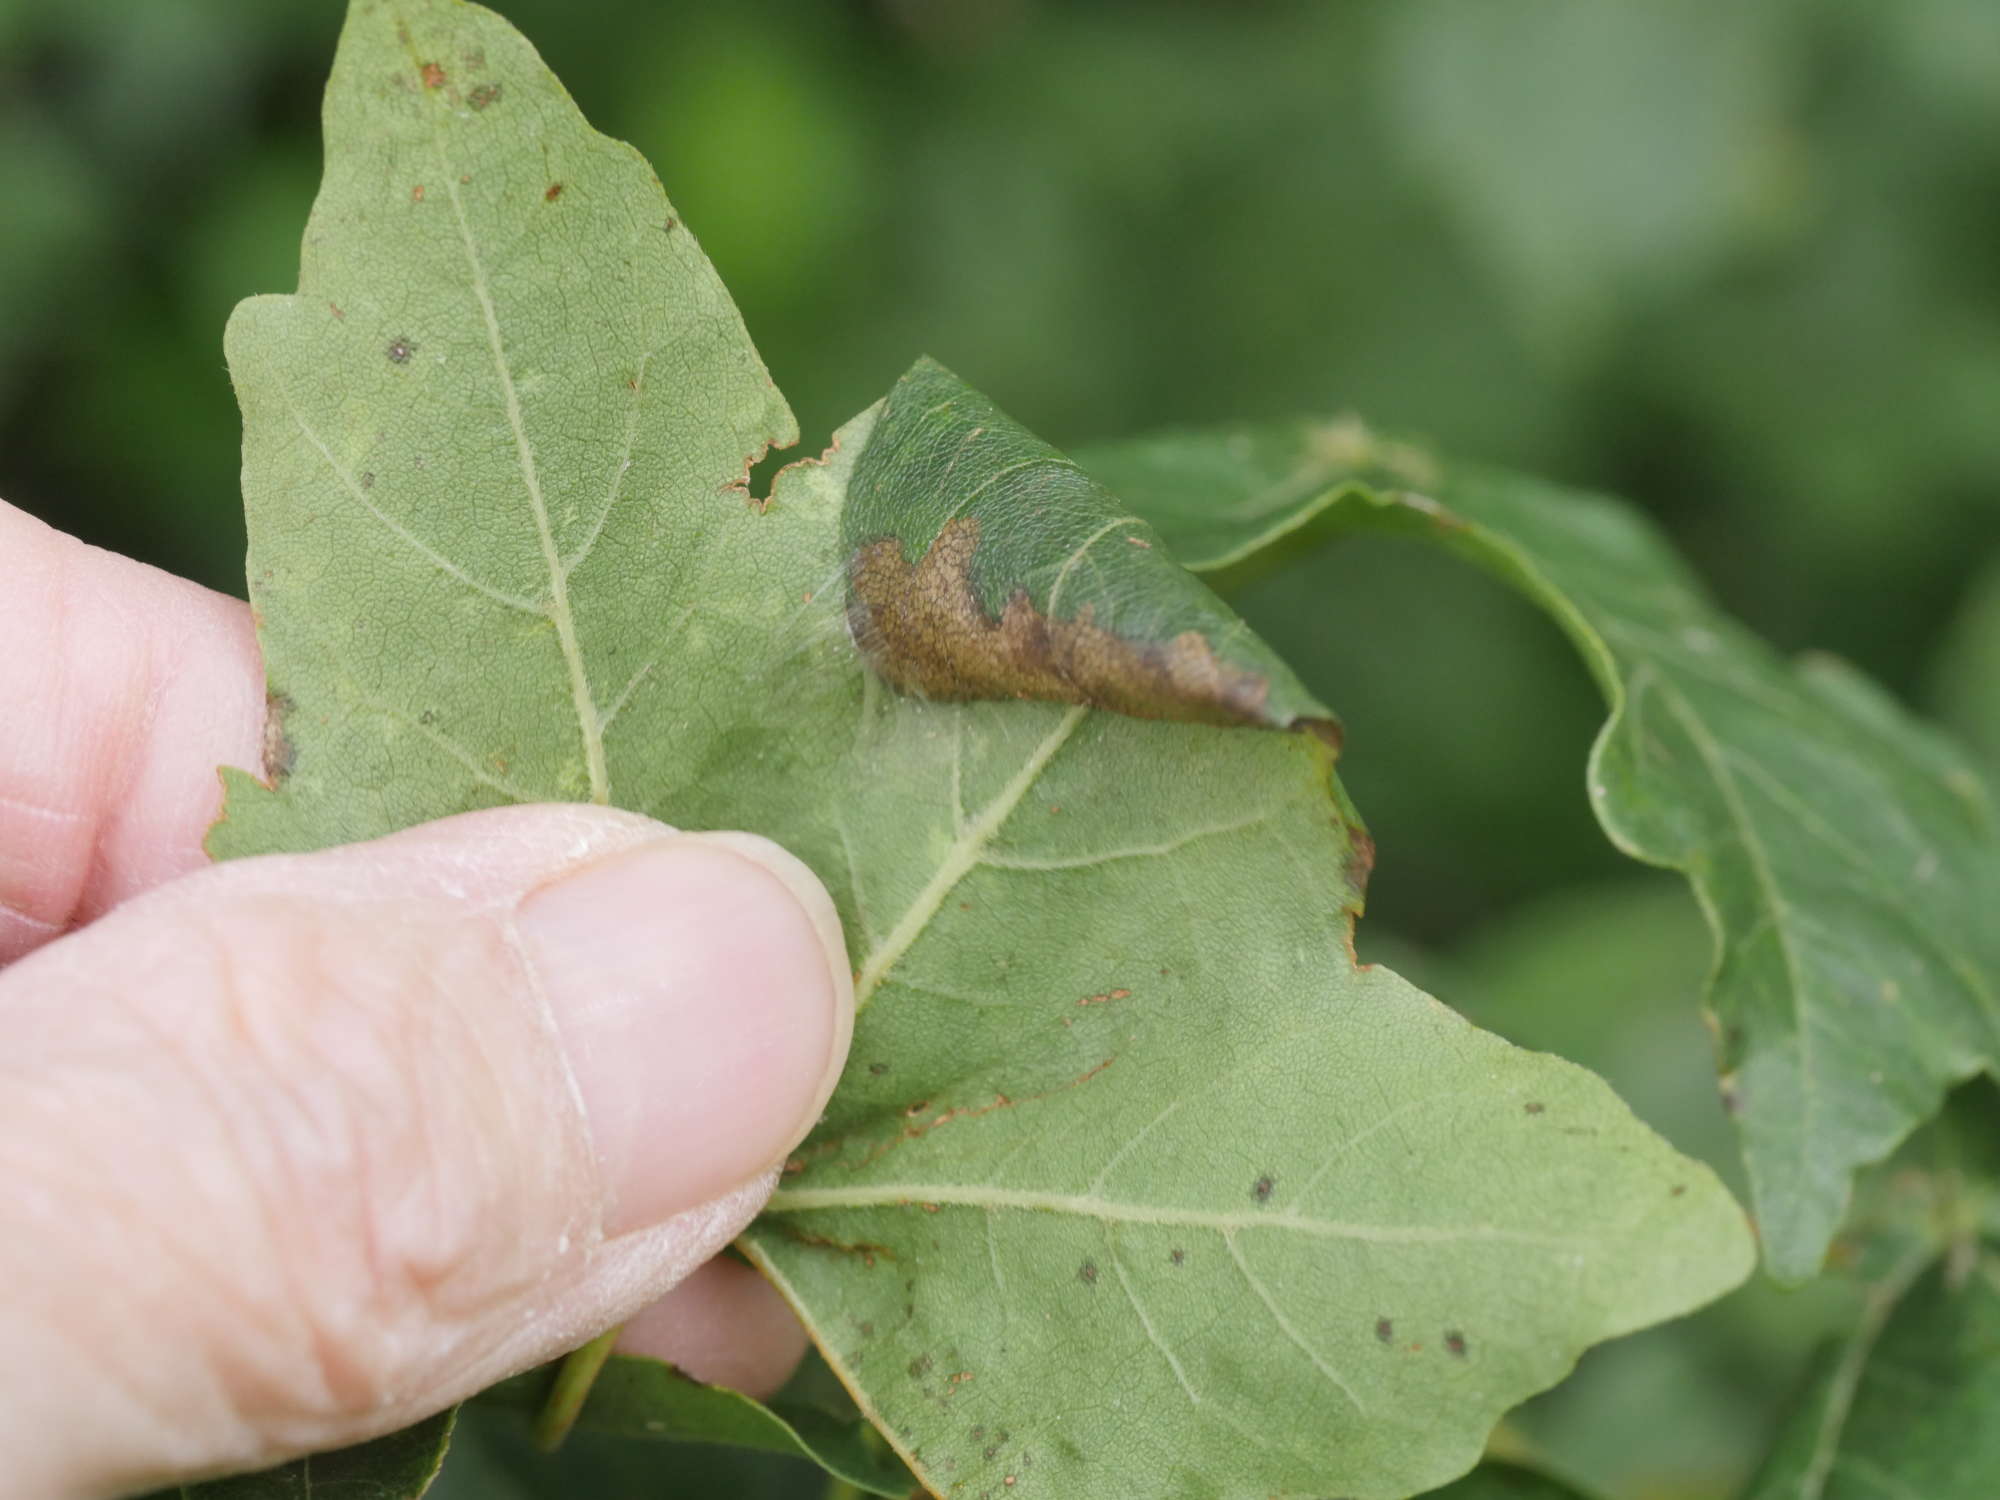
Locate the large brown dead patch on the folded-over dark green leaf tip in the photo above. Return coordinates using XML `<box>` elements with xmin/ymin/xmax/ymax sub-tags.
<box><xmin>848</xmin><ymin>516</ymin><xmax>1330</xmax><ymax>732</ymax></box>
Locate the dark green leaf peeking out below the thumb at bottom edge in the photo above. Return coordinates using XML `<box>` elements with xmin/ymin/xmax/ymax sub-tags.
<box><xmin>480</xmin><ymin>1354</ymin><xmax>916</xmax><ymax>1500</ymax></box>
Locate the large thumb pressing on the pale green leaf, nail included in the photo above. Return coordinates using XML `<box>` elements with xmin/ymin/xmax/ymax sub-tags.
<box><xmin>0</xmin><ymin>806</ymin><xmax>854</xmax><ymax>1496</ymax></box>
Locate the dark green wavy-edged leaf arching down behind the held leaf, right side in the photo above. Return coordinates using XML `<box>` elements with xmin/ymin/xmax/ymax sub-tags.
<box><xmin>1086</xmin><ymin>422</ymin><xmax>2000</xmax><ymax>1280</ymax></box>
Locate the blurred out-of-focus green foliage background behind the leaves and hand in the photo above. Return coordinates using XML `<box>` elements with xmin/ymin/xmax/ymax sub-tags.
<box><xmin>0</xmin><ymin>0</ymin><xmax>2000</xmax><ymax>1500</ymax></box>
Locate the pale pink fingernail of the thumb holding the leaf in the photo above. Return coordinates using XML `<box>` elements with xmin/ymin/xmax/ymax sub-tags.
<box><xmin>516</xmin><ymin>834</ymin><xmax>854</xmax><ymax>1234</ymax></box>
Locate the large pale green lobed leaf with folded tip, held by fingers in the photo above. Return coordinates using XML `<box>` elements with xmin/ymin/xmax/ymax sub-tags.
<box><xmin>212</xmin><ymin>0</ymin><xmax>1750</xmax><ymax>1500</ymax></box>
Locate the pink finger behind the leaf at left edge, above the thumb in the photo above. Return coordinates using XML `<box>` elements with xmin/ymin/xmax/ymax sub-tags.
<box><xmin>0</xmin><ymin>504</ymin><xmax>264</xmax><ymax>962</ymax></box>
